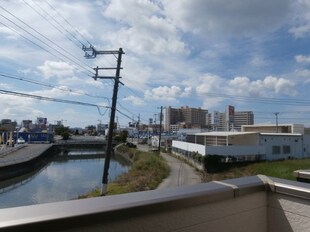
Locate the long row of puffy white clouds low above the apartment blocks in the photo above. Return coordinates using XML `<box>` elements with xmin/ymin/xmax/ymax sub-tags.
<box><xmin>185</xmin><ymin>74</ymin><xmax>296</xmax><ymax>109</ymax></box>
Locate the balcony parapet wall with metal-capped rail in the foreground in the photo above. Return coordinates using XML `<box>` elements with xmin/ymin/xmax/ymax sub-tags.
<box><xmin>0</xmin><ymin>176</ymin><xmax>310</xmax><ymax>232</ymax></box>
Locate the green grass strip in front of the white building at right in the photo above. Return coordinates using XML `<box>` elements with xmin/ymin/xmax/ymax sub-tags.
<box><xmin>205</xmin><ymin>159</ymin><xmax>310</xmax><ymax>181</ymax></box>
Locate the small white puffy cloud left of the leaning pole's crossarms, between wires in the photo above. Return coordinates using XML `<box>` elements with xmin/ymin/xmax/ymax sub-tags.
<box><xmin>38</xmin><ymin>60</ymin><xmax>74</xmax><ymax>79</ymax></box>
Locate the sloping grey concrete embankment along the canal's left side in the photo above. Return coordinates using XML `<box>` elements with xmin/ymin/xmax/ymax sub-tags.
<box><xmin>0</xmin><ymin>144</ymin><xmax>57</xmax><ymax>181</ymax></box>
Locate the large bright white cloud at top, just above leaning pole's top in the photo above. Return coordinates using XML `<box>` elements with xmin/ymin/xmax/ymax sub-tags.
<box><xmin>103</xmin><ymin>0</ymin><xmax>186</xmax><ymax>55</ymax></box>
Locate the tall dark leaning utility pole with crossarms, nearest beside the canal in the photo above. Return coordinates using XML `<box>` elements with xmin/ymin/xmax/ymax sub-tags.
<box><xmin>83</xmin><ymin>46</ymin><xmax>124</xmax><ymax>196</ymax></box>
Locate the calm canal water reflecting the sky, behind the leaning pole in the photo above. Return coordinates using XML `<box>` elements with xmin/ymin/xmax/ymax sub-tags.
<box><xmin>0</xmin><ymin>150</ymin><xmax>128</xmax><ymax>208</ymax></box>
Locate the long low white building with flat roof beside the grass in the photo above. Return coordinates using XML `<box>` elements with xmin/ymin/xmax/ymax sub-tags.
<box><xmin>172</xmin><ymin>132</ymin><xmax>310</xmax><ymax>161</ymax></box>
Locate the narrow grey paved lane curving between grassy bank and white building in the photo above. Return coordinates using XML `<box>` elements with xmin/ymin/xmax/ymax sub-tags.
<box><xmin>138</xmin><ymin>145</ymin><xmax>201</xmax><ymax>189</ymax></box>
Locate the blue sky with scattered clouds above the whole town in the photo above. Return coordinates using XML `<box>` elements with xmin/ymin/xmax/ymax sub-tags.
<box><xmin>0</xmin><ymin>0</ymin><xmax>310</xmax><ymax>127</ymax></box>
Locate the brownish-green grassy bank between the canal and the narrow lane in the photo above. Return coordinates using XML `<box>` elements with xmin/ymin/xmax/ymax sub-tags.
<box><xmin>78</xmin><ymin>144</ymin><xmax>169</xmax><ymax>199</ymax></box>
